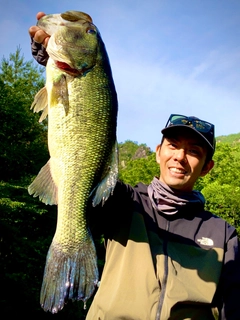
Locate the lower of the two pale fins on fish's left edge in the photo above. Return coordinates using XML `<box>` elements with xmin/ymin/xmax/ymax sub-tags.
<box><xmin>28</xmin><ymin>160</ymin><xmax>58</xmax><ymax>205</ymax></box>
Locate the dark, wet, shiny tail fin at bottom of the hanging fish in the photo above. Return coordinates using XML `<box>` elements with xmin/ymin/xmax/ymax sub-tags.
<box><xmin>40</xmin><ymin>231</ymin><xmax>98</xmax><ymax>313</ymax></box>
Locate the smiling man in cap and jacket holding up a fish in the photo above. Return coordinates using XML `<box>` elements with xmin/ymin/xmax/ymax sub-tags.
<box><xmin>29</xmin><ymin>13</ymin><xmax>240</xmax><ymax>320</ymax></box>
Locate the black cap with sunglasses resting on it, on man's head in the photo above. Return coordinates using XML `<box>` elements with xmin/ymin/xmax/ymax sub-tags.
<box><xmin>161</xmin><ymin>114</ymin><xmax>216</xmax><ymax>156</ymax></box>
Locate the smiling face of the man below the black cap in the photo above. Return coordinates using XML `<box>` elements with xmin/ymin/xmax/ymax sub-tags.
<box><xmin>156</xmin><ymin>130</ymin><xmax>214</xmax><ymax>192</ymax></box>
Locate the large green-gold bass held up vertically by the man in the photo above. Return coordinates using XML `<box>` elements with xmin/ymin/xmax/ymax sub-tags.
<box><xmin>28</xmin><ymin>10</ymin><xmax>118</xmax><ymax>313</ymax></box>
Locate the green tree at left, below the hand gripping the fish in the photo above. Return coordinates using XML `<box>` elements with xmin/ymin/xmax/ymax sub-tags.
<box><xmin>0</xmin><ymin>49</ymin><xmax>48</xmax><ymax>181</ymax></box>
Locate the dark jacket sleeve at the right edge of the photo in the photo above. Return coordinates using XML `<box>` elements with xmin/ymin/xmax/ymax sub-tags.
<box><xmin>219</xmin><ymin>226</ymin><xmax>240</xmax><ymax>320</ymax></box>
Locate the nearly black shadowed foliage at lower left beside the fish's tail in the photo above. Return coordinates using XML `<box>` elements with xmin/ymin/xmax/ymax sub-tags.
<box><xmin>0</xmin><ymin>182</ymin><xmax>53</xmax><ymax>315</ymax></box>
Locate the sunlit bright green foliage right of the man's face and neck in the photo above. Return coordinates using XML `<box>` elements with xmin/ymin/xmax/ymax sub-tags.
<box><xmin>195</xmin><ymin>143</ymin><xmax>240</xmax><ymax>236</ymax></box>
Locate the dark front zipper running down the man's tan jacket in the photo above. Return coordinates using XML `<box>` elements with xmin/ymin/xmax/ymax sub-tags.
<box><xmin>156</xmin><ymin>220</ymin><xmax>170</xmax><ymax>320</ymax></box>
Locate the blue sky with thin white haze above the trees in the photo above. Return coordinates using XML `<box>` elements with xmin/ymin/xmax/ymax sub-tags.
<box><xmin>0</xmin><ymin>0</ymin><xmax>240</xmax><ymax>150</ymax></box>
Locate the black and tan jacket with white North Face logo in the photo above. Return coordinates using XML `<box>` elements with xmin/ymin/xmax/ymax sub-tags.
<box><xmin>87</xmin><ymin>183</ymin><xmax>240</xmax><ymax>320</ymax></box>
